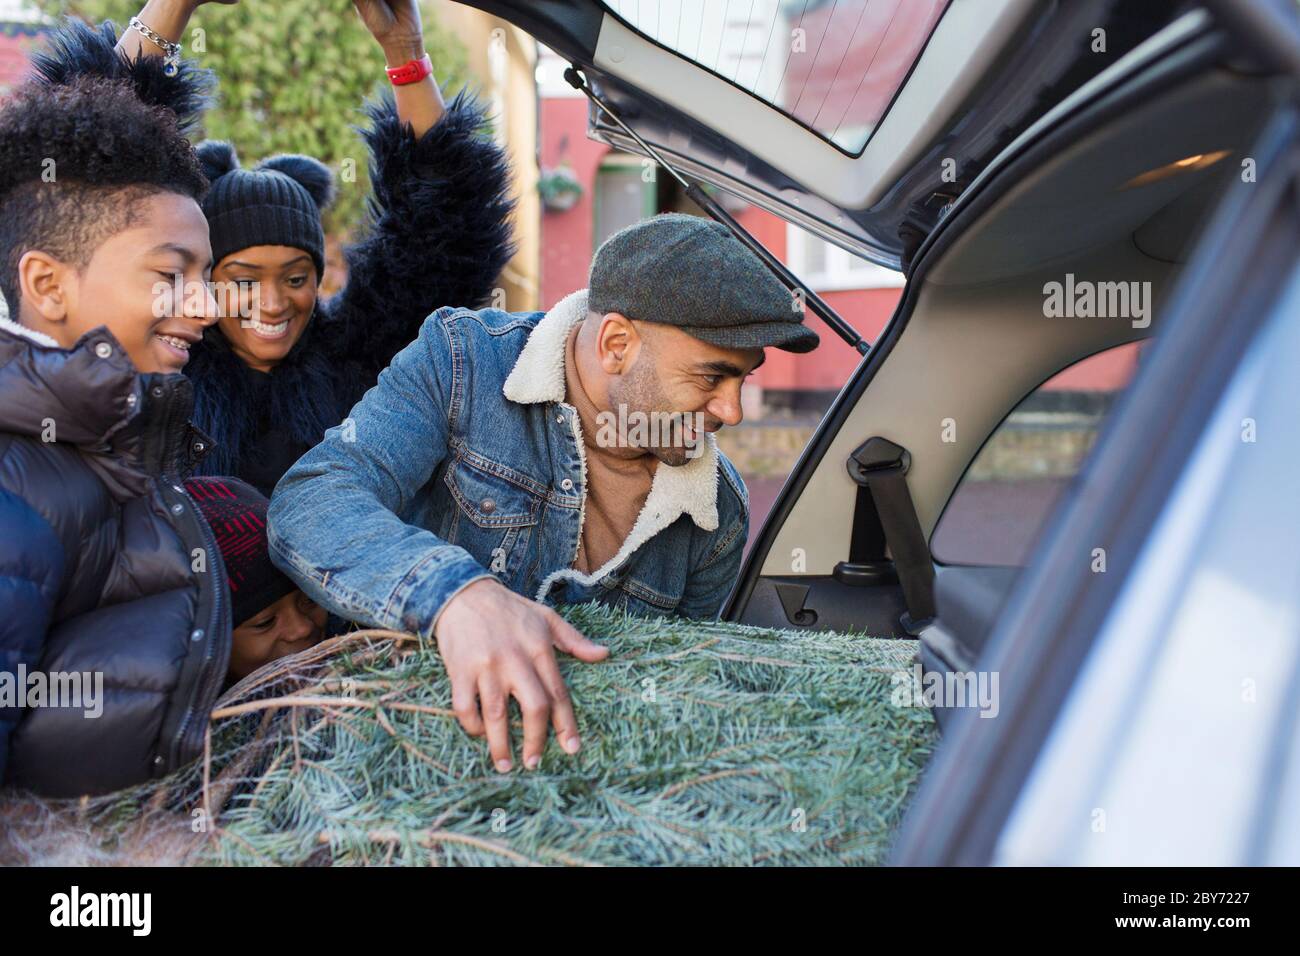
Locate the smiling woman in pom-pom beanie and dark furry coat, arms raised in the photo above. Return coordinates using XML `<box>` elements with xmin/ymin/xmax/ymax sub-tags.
<box><xmin>189</xmin><ymin>74</ymin><xmax>512</xmax><ymax>496</ymax></box>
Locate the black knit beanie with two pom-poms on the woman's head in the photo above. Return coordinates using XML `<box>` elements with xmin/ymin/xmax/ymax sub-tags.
<box><xmin>195</xmin><ymin>139</ymin><xmax>334</xmax><ymax>278</ymax></box>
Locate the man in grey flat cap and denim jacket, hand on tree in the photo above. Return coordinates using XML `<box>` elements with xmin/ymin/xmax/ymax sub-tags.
<box><xmin>269</xmin><ymin>213</ymin><xmax>818</xmax><ymax>771</ymax></box>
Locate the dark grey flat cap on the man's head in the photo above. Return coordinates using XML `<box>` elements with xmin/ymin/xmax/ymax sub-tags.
<box><xmin>588</xmin><ymin>212</ymin><xmax>819</xmax><ymax>352</ymax></box>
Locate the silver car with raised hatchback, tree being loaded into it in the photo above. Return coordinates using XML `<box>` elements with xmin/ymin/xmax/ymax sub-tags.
<box><xmin>462</xmin><ymin>0</ymin><xmax>1300</xmax><ymax>864</ymax></box>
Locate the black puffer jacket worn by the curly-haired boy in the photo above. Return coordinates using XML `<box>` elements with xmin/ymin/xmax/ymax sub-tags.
<box><xmin>0</xmin><ymin>321</ymin><xmax>230</xmax><ymax>796</ymax></box>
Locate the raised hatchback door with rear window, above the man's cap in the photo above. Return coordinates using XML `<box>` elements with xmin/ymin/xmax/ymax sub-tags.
<box><xmin>469</xmin><ymin>0</ymin><xmax>1178</xmax><ymax>269</ymax></box>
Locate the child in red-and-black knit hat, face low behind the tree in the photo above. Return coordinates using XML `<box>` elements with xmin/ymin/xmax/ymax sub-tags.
<box><xmin>185</xmin><ymin>477</ymin><xmax>328</xmax><ymax>683</ymax></box>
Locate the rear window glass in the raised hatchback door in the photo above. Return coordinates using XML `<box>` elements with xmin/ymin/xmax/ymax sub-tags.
<box><xmin>605</xmin><ymin>0</ymin><xmax>948</xmax><ymax>155</ymax></box>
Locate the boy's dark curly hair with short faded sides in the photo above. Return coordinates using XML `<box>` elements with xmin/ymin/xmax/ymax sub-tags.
<box><xmin>0</xmin><ymin>77</ymin><xmax>208</xmax><ymax>317</ymax></box>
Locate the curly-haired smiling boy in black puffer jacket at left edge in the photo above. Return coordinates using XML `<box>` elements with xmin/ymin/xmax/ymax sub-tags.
<box><xmin>0</xmin><ymin>26</ymin><xmax>230</xmax><ymax>796</ymax></box>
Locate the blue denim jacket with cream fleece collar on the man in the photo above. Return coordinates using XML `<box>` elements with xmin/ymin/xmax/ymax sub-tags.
<box><xmin>268</xmin><ymin>290</ymin><xmax>749</xmax><ymax>636</ymax></box>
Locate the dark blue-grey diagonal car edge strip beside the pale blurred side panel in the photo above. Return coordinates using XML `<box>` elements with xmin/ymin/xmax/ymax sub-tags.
<box><xmin>893</xmin><ymin>69</ymin><xmax>1300</xmax><ymax>865</ymax></box>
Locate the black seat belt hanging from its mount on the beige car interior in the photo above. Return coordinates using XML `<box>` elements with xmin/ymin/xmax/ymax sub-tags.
<box><xmin>837</xmin><ymin>436</ymin><xmax>935</xmax><ymax>632</ymax></box>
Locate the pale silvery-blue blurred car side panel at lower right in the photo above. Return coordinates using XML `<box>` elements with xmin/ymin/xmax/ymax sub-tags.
<box><xmin>995</xmin><ymin>269</ymin><xmax>1300</xmax><ymax>866</ymax></box>
